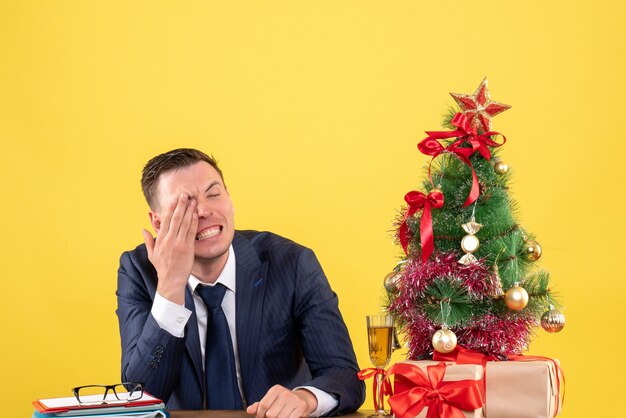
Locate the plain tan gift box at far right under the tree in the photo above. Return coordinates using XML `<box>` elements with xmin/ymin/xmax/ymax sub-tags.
<box><xmin>485</xmin><ymin>357</ymin><xmax>563</xmax><ymax>418</ymax></box>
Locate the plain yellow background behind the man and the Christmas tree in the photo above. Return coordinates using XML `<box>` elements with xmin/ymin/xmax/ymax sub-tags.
<box><xmin>0</xmin><ymin>0</ymin><xmax>626</xmax><ymax>417</ymax></box>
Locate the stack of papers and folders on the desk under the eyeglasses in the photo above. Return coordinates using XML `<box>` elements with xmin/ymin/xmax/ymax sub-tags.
<box><xmin>33</xmin><ymin>392</ymin><xmax>168</xmax><ymax>418</ymax></box>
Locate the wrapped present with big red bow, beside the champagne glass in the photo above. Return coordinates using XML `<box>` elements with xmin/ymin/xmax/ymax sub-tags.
<box><xmin>387</xmin><ymin>360</ymin><xmax>485</xmax><ymax>418</ymax></box>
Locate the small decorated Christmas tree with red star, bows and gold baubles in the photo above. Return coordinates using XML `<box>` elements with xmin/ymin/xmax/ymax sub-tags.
<box><xmin>385</xmin><ymin>79</ymin><xmax>565</xmax><ymax>359</ymax></box>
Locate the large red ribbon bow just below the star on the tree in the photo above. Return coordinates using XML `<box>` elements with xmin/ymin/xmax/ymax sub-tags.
<box><xmin>417</xmin><ymin>113</ymin><xmax>506</xmax><ymax>207</ymax></box>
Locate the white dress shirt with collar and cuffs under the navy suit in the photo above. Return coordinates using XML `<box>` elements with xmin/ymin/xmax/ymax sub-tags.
<box><xmin>151</xmin><ymin>245</ymin><xmax>339</xmax><ymax>417</ymax></box>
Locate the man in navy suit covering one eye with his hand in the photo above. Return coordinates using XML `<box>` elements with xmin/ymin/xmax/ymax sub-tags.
<box><xmin>117</xmin><ymin>149</ymin><xmax>364</xmax><ymax>417</ymax></box>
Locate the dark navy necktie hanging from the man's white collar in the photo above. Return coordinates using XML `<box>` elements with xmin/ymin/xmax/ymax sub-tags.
<box><xmin>196</xmin><ymin>283</ymin><xmax>243</xmax><ymax>409</ymax></box>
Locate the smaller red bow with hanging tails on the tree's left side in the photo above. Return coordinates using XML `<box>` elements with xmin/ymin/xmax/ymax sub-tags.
<box><xmin>399</xmin><ymin>189</ymin><xmax>443</xmax><ymax>263</ymax></box>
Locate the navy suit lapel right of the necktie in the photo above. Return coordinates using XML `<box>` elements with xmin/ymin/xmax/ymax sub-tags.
<box><xmin>233</xmin><ymin>233</ymin><xmax>268</xmax><ymax>393</ymax></box>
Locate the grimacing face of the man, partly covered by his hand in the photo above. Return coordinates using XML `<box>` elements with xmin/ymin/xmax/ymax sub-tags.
<box><xmin>150</xmin><ymin>161</ymin><xmax>235</xmax><ymax>264</ymax></box>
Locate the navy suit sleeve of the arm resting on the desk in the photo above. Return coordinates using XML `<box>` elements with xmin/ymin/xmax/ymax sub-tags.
<box><xmin>294</xmin><ymin>249</ymin><xmax>365</xmax><ymax>415</ymax></box>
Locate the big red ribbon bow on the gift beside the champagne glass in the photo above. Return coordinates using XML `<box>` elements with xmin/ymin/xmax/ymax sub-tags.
<box><xmin>387</xmin><ymin>362</ymin><xmax>484</xmax><ymax>418</ymax></box>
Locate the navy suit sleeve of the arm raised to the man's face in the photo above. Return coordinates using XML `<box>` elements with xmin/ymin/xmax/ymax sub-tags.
<box><xmin>116</xmin><ymin>252</ymin><xmax>184</xmax><ymax>402</ymax></box>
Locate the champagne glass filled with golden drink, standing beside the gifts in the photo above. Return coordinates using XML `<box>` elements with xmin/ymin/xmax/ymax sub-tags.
<box><xmin>367</xmin><ymin>315</ymin><xmax>393</xmax><ymax>418</ymax></box>
